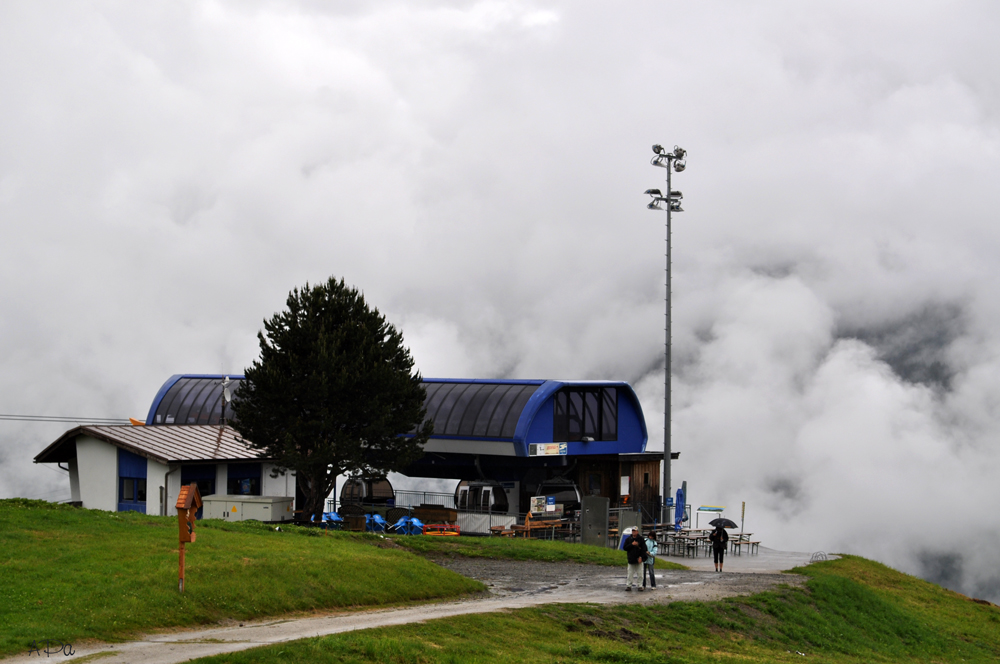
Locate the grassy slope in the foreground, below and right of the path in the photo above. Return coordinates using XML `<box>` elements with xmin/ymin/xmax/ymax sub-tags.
<box><xmin>186</xmin><ymin>556</ymin><xmax>1000</xmax><ymax>664</ymax></box>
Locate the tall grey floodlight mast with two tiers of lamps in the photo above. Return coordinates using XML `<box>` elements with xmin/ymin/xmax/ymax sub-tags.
<box><xmin>646</xmin><ymin>145</ymin><xmax>687</xmax><ymax>524</ymax></box>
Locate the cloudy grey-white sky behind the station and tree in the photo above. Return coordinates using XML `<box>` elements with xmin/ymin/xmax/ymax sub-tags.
<box><xmin>0</xmin><ymin>0</ymin><xmax>1000</xmax><ymax>601</ymax></box>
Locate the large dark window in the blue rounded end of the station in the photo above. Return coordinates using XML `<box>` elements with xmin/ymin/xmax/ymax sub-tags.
<box><xmin>552</xmin><ymin>387</ymin><xmax>618</xmax><ymax>442</ymax></box>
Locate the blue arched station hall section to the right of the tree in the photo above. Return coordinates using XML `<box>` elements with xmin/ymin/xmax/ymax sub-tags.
<box><xmin>403</xmin><ymin>378</ymin><xmax>662</xmax><ymax>515</ymax></box>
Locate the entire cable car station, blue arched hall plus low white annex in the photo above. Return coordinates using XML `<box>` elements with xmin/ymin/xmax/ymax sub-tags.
<box><xmin>35</xmin><ymin>375</ymin><xmax>662</xmax><ymax>516</ymax></box>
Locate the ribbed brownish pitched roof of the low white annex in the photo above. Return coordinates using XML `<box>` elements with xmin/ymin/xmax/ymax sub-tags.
<box><xmin>35</xmin><ymin>425</ymin><xmax>265</xmax><ymax>464</ymax></box>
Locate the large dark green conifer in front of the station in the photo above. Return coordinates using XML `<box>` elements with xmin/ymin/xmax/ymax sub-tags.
<box><xmin>233</xmin><ymin>277</ymin><xmax>433</xmax><ymax>520</ymax></box>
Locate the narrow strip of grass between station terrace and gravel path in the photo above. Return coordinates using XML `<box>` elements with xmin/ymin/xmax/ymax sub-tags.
<box><xmin>393</xmin><ymin>535</ymin><xmax>687</xmax><ymax>570</ymax></box>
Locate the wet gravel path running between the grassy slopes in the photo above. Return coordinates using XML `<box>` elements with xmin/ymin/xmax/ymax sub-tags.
<box><xmin>0</xmin><ymin>552</ymin><xmax>808</xmax><ymax>664</ymax></box>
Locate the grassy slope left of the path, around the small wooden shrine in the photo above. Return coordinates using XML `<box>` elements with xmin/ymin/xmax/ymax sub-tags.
<box><xmin>0</xmin><ymin>499</ymin><xmax>484</xmax><ymax>656</ymax></box>
